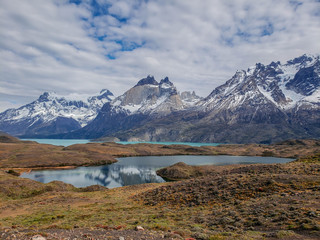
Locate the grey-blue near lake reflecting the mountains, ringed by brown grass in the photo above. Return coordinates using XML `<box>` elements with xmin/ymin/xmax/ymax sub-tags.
<box><xmin>21</xmin><ymin>155</ymin><xmax>292</xmax><ymax>188</ymax></box>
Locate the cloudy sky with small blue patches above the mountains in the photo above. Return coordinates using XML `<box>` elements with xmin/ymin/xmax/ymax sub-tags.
<box><xmin>0</xmin><ymin>0</ymin><xmax>320</xmax><ymax>111</ymax></box>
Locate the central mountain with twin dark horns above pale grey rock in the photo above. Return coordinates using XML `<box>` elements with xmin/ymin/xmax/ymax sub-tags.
<box><xmin>63</xmin><ymin>76</ymin><xmax>195</xmax><ymax>138</ymax></box>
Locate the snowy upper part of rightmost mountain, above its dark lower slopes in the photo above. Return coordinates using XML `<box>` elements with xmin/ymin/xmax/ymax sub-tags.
<box><xmin>198</xmin><ymin>55</ymin><xmax>320</xmax><ymax>111</ymax></box>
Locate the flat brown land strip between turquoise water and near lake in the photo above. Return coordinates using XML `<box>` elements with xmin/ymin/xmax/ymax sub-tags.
<box><xmin>0</xmin><ymin>140</ymin><xmax>320</xmax><ymax>171</ymax></box>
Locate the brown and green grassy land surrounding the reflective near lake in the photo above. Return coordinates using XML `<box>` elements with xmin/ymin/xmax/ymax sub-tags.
<box><xmin>0</xmin><ymin>136</ymin><xmax>320</xmax><ymax>239</ymax></box>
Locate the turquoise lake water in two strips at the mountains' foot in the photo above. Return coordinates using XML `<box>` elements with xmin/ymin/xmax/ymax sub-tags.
<box><xmin>21</xmin><ymin>139</ymin><xmax>219</xmax><ymax>147</ymax></box>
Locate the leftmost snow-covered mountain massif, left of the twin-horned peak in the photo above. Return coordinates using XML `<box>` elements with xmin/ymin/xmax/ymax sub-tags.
<box><xmin>0</xmin><ymin>89</ymin><xmax>114</xmax><ymax>136</ymax></box>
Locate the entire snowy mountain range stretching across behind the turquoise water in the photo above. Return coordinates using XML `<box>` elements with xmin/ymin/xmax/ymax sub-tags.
<box><xmin>0</xmin><ymin>55</ymin><xmax>320</xmax><ymax>143</ymax></box>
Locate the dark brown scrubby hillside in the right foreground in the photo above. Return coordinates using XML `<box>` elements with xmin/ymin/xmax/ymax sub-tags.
<box><xmin>135</xmin><ymin>162</ymin><xmax>320</xmax><ymax>239</ymax></box>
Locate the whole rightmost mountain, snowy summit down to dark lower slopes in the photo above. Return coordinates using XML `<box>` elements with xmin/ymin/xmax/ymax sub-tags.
<box><xmin>110</xmin><ymin>55</ymin><xmax>320</xmax><ymax>143</ymax></box>
